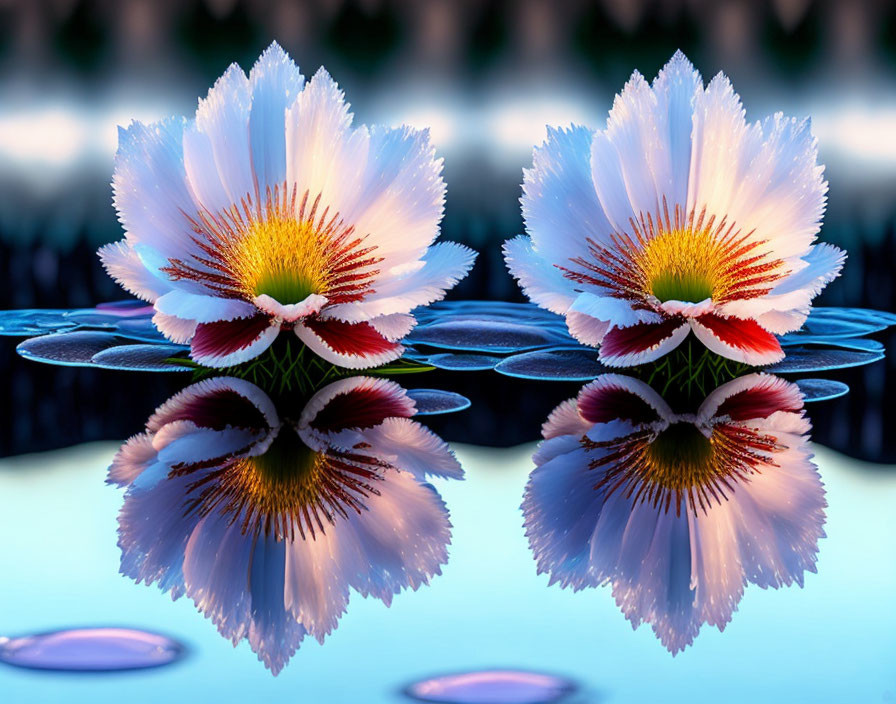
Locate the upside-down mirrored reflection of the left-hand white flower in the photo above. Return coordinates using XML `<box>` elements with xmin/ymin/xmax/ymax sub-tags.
<box><xmin>109</xmin><ymin>377</ymin><xmax>463</xmax><ymax>674</ymax></box>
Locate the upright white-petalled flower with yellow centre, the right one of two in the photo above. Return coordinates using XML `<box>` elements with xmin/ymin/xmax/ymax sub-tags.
<box><xmin>505</xmin><ymin>52</ymin><xmax>845</xmax><ymax>366</ymax></box>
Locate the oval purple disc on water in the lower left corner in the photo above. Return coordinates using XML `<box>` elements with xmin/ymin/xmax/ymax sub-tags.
<box><xmin>0</xmin><ymin>627</ymin><xmax>186</xmax><ymax>672</ymax></box>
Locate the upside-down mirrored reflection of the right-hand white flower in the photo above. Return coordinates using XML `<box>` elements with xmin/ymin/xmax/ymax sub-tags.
<box><xmin>522</xmin><ymin>374</ymin><xmax>827</xmax><ymax>654</ymax></box>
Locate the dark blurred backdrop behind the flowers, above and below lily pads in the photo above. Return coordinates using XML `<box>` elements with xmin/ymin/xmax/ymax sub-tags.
<box><xmin>0</xmin><ymin>0</ymin><xmax>896</xmax><ymax>462</ymax></box>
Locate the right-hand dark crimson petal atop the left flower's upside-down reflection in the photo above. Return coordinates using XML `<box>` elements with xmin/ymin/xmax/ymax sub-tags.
<box><xmin>310</xmin><ymin>384</ymin><xmax>414</xmax><ymax>432</ymax></box>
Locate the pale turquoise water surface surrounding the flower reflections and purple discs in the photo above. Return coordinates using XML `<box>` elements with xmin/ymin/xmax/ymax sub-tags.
<box><xmin>0</xmin><ymin>443</ymin><xmax>896</xmax><ymax>704</ymax></box>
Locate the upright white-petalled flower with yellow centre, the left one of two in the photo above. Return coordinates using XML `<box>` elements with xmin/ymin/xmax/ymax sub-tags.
<box><xmin>100</xmin><ymin>43</ymin><xmax>474</xmax><ymax>368</ymax></box>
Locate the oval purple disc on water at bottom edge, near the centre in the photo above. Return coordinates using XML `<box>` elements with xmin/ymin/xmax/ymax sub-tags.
<box><xmin>405</xmin><ymin>670</ymin><xmax>576</xmax><ymax>704</ymax></box>
